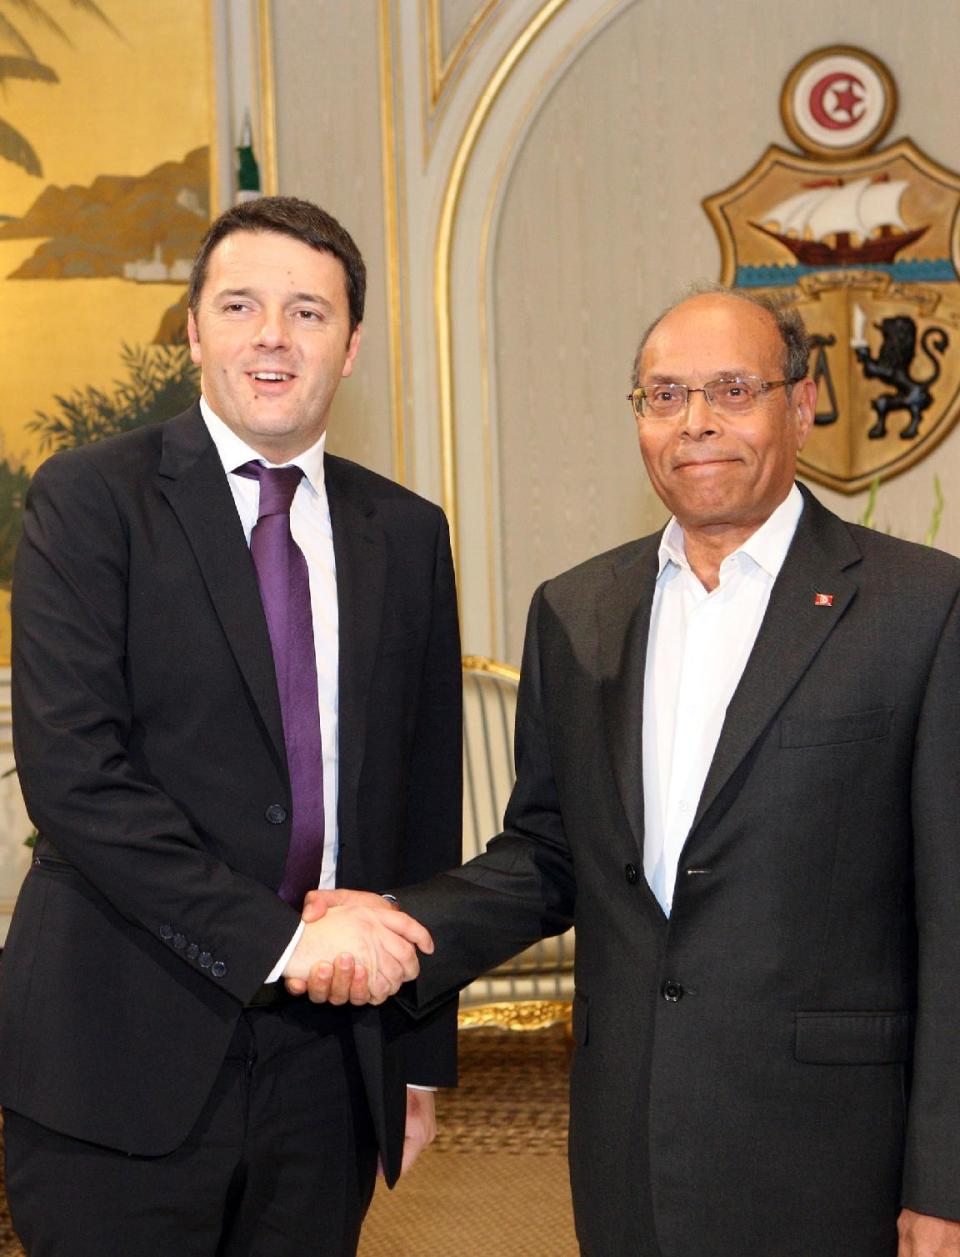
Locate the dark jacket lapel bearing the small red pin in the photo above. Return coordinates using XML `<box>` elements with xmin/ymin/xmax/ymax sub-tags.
<box><xmin>690</xmin><ymin>486</ymin><xmax>859</xmax><ymax>836</ymax></box>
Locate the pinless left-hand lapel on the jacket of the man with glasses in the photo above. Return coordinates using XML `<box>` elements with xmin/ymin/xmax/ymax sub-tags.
<box><xmin>596</xmin><ymin>534</ymin><xmax>660</xmax><ymax>852</ymax></box>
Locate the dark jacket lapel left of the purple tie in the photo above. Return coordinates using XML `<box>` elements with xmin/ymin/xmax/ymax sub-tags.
<box><xmin>160</xmin><ymin>406</ymin><xmax>286</xmax><ymax>766</ymax></box>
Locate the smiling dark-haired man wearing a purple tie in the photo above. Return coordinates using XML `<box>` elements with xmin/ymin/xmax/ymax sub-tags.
<box><xmin>0</xmin><ymin>197</ymin><xmax>461</xmax><ymax>1257</ymax></box>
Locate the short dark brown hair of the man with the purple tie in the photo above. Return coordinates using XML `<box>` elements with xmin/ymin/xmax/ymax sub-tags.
<box><xmin>187</xmin><ymin>196</ymin><xmax>367</xmax><ymax>332</ymax></box>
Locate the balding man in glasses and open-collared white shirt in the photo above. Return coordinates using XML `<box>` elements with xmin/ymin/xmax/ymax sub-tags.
<box><xmin>307</xmin><ymin>292</ymin><xmax>960</xmax><ymax>1257</ymax></box>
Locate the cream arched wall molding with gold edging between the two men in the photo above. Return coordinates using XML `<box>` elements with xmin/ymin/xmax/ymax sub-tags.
<box><xmin>381</xmin><ymin>0</ymin><xmax>631</xmax><ymax>655</ymax></box>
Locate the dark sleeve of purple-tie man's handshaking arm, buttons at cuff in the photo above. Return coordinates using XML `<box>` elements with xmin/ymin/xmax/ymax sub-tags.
<box><xmin>11</xmin><ymin>449</ymin><xmax>298</xmax><ymax>1001</ymax></box>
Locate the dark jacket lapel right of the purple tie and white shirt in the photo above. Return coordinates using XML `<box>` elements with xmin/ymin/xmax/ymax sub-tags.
<box><xmin>324</xmin><ymin>456</ymin><xmax>387</xmax><ymax>885</ymax></box>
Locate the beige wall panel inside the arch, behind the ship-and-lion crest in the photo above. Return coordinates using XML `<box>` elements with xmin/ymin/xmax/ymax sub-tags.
<box><xmin>495</xmin><ymin>0</ymin><xmax>960</xmax><ymax>659</ymax></box>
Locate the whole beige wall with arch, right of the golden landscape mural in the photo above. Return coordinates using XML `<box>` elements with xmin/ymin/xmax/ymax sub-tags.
<box><xmin>266</xmin><ymin>0</ymin><xmax>960</xmax><ymax>662</ymax></box>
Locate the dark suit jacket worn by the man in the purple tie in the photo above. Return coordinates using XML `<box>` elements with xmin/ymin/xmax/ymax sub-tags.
<box><xmin>0</xmin><ymin>407</ymin><xmax>461</xmax><ymax>1179</ymax></box>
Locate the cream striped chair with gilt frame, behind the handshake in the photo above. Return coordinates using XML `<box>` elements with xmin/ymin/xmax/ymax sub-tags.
<box><xmin>460</xmin><ymin>655</ymin><xmax>574</xmax><ymax>1028</ymax></box>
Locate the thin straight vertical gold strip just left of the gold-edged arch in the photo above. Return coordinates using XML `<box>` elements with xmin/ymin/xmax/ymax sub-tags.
<box><xmin>378</xmin><ymin>0</ymin><xmax>406</xmax><ymax>484</ymax></box>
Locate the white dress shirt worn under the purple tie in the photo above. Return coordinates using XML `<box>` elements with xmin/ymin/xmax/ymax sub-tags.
<box><xmin>200</xmin><ymin>397</ymin><xmax>339</xmax><ymax>982</ymax></box>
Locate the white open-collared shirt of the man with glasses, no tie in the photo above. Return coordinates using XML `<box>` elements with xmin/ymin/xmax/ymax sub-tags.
<box><xmin>643</xmin><ymin>485</ymin><xmax>803</xmax><ymax>916</ymax></box>
